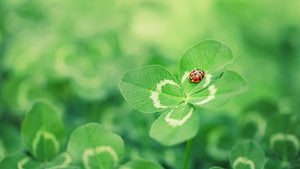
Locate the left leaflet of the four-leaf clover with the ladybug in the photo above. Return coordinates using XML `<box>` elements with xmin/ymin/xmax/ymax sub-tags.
<box><xmin>120</xmin><ymin>65</ymin><xmax>184</xmax><ymax>113</ymax></box>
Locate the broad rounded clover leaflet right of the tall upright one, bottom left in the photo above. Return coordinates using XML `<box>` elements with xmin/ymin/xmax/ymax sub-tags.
<box><xmin>68</xmin><ymin>123</ymin><xmax>124</xmax><ymax>169</ymax></box>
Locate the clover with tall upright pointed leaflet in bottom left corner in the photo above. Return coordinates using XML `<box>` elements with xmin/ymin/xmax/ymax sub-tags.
<box><xmin>0</xmin><ymin>101</ymin><xmax>79</xmax><ymax>169</ymax></box>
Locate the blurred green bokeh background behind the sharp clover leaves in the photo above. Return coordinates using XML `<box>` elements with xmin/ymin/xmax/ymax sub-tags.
<box><xmin>0</xmin><ymin>0</ymin><xmax>300</xmax><ymax>169</ymax></box>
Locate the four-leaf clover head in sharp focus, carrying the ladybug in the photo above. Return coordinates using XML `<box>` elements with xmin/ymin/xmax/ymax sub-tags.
<box><xmin>120</xmin><ymin>40</ymin><xmax>247</xmax><ymax>145</ymax></box>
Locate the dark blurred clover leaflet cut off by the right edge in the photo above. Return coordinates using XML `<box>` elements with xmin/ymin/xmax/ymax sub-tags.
<box><xmin>264</xmin><ymin>114</ymin><xmax>300</xmax><ymax>169</ymax></box>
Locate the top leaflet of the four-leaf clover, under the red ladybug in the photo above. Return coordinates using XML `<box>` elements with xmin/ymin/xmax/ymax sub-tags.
<box><xmin>179</xmin><ymin>40</ymin><xmax>233</xmax><ymax>94</ymax></box>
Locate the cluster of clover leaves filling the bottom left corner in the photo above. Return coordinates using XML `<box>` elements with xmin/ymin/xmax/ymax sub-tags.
<box><xmin>0</xmin><ymin>101</ymin><xmax>162</xmax><ymax>169</ymax></box>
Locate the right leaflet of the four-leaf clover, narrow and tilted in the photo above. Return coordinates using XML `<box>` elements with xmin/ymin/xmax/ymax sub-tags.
<box><xmin>188</xmin><ymin>71</ymin><xmax>247</xmax><ymax>108</ymax></box>
